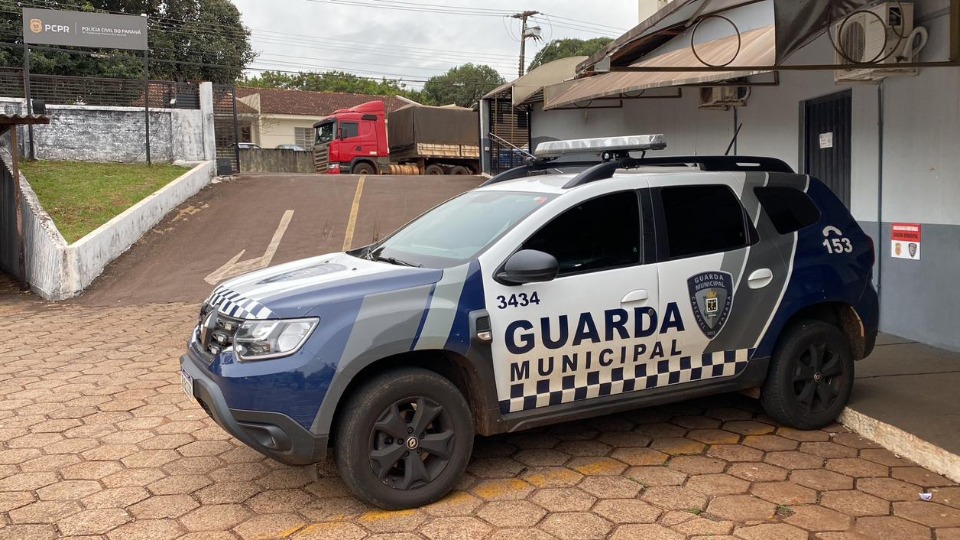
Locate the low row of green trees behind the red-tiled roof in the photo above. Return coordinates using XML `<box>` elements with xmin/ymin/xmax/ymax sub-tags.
<box><xmin>243</xmin><ymin>71</ymin><xmax>418</xmax><ymax>100</ymax></box>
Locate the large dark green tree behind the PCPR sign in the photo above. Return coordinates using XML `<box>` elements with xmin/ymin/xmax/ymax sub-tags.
<box><xmin>0</xmin><ymin>0</ymin><xmax>256</xmax><ymax>83</ymax></box>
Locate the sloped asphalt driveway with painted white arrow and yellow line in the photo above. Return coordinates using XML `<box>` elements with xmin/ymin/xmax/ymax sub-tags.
<box><xmin>75</xmin><ymin>174</ymin><xmax>482</xmax><ymax>305</ymax></box>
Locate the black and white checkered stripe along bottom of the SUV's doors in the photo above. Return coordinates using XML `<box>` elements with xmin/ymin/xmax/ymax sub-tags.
<box><xmin>500</xmin><ymin>349</ymin><xmax>755</xmax><ymax>414</ymax></box>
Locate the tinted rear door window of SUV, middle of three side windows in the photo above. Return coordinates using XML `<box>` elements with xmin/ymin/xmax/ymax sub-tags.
<box><xmin>659</xmin><ymin>186</ymin><xmax>756</xmax><ymax>259</ymax></box>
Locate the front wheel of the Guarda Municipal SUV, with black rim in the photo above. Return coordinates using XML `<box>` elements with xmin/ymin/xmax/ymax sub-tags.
<box><xmin>334</xmin><ymin>368</ymin><xmax>474</xmax><ymax>510</ymax></box>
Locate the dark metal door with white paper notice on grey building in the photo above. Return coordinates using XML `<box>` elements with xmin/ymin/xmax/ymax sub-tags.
<box><xmin>803</xmin><ymin>90</ymin><xmax>853</xmax><ymax>208</ymax></box>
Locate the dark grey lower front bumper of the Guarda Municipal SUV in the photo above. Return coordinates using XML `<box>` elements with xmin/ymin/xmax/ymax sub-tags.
<box><xmin>180</xmin><ymin>354</ymin><xmax>328</xmax><ymax>465</ymax></box>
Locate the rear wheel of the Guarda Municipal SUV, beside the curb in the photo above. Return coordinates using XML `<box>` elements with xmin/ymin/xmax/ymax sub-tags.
<box><xmin>760</xmin><ymin>321</ymin><xmax>854</xmax><ymax>429</ymax></box>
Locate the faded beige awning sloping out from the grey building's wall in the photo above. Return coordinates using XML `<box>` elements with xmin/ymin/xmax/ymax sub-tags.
<box><xmin>543</xmin><ymin>25</ymin><xmax>776</xmax><ymax>109</ymax></box>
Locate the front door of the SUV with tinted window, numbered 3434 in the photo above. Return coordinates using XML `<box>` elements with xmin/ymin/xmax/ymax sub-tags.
<box><xmin>484</xmin><ymin>190</ymin><xmax>664</xmax><ymax>414</ymax></box>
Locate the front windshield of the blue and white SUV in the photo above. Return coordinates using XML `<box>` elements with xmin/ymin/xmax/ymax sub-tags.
<box><xmin>360</xmin><ymin>191</ymin><xmax>555</xmax><ymax>268</ymax></box>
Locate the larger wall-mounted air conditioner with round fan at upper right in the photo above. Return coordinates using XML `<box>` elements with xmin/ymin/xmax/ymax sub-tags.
<box><xmin>830</xmin><ymin>2</ymin><xmax>927</xmax><ymax>82</ymax></box>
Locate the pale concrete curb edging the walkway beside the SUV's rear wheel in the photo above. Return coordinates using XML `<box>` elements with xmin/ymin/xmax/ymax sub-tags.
<box><xmin>839</xmin><ymin>407</ymin><xmax>960</xmax><ymax>482</ymax></box>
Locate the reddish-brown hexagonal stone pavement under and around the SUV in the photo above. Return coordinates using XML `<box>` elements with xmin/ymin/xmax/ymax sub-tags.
<box><xmin>0</xmin><ymin>297</ymin><xmax>960</xmax><ymax>540</ymax></box>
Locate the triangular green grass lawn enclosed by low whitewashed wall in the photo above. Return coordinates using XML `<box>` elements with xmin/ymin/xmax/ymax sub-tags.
<box><xmin>20</xmin><ymin>161</ymin><xmax>189</xmax><ymax>244</ymax></box>
